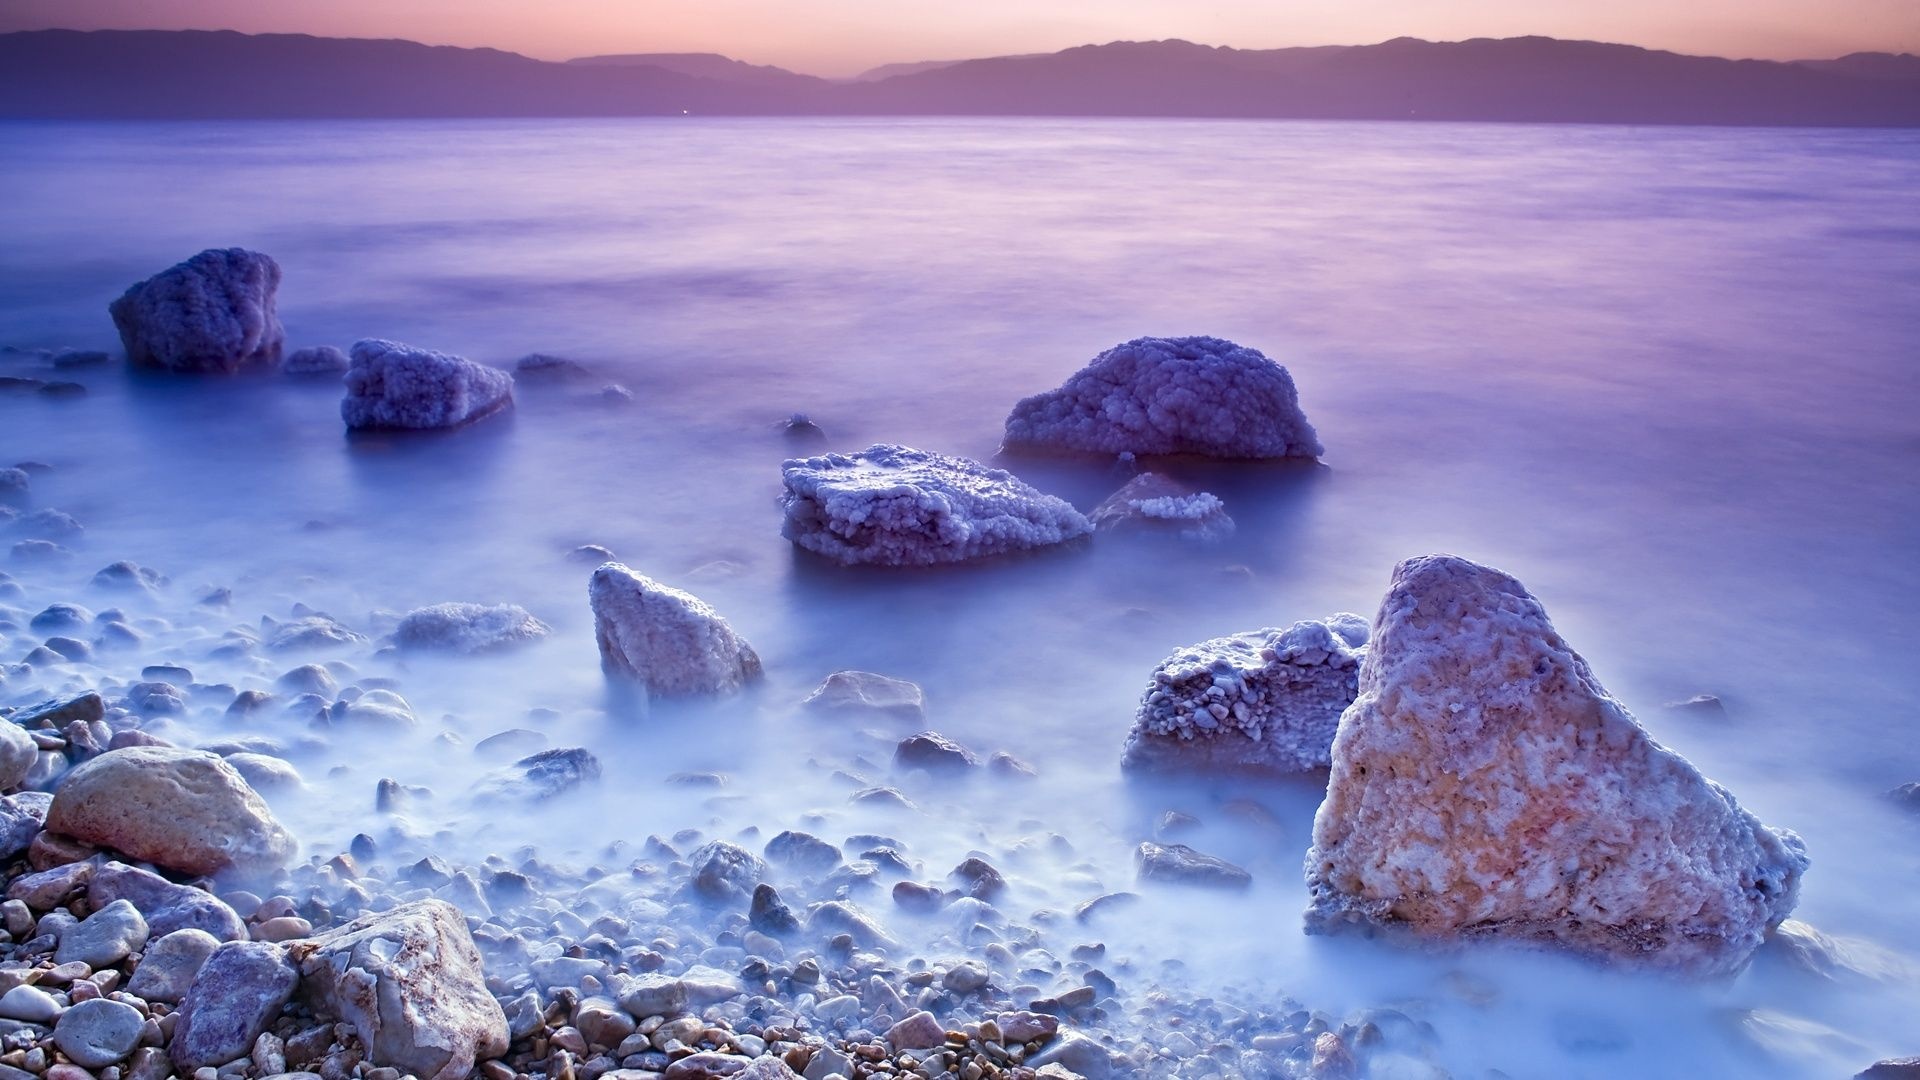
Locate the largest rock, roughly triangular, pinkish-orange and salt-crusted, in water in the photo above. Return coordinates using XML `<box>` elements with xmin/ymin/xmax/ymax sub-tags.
<box><xmin>1306</xmin><ymin>555</ymin><xmax>1807</xmax><ymax>974</ymax></box>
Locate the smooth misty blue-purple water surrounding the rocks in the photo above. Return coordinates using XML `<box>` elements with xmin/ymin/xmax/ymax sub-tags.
<box><xmin>0</xmin><ymin>121</ymin><xmax>1920</xmax><ymax>1076</ymax></box>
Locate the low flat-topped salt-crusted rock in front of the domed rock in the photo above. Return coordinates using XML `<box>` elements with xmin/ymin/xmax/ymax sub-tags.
<box><xmin>780</xmin><ymin>444</ymin><xmax>1092</xmax><ymax>567</ymax></box>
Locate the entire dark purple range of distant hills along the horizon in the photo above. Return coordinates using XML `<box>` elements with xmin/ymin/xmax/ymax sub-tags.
<box><xmin>0</xmin><ymin>31</ymin><xmax>1920</xmax><ymax>127</ymax></box>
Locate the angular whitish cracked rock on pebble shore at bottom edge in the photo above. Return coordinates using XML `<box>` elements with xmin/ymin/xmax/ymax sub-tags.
<box><xmin>294</xmin><ymin>899</ymin><xmax>507</xmax><ymax>1080</ymax></box>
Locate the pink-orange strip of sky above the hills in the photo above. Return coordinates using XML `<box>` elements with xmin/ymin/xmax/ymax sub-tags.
<box><xmin>0</xmin><ymin>0</ymin><xmax>1920</xmax><ymax>77</ymax></box>
